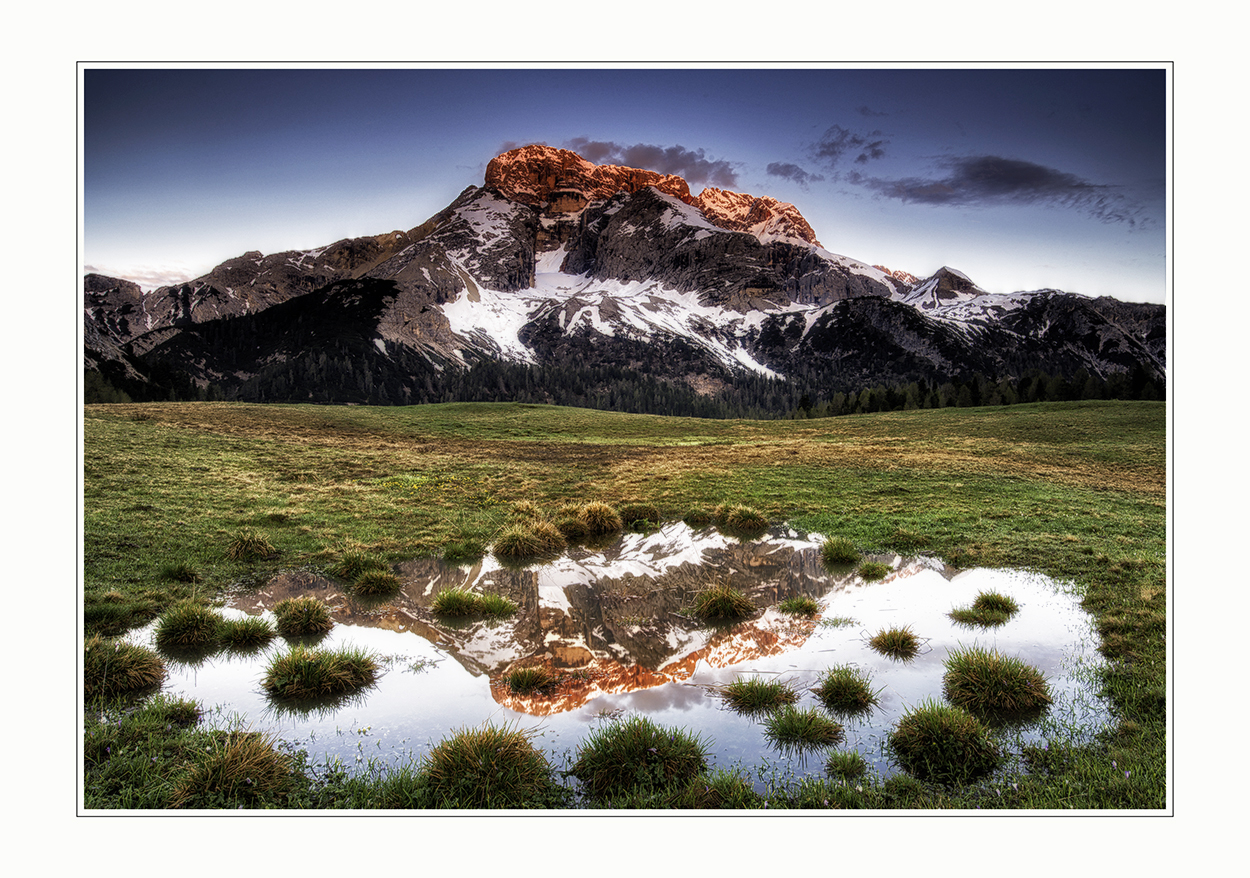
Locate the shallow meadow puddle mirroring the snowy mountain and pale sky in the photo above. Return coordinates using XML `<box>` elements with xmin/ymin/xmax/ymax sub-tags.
<box><xmin>121</xmin><ymin>523</ymin><xmax>1109</xmax><ymax>775</ymax></box>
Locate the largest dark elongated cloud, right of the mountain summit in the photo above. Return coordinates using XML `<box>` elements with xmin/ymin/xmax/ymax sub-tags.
<box><xmin>846</xmin><ymin>155</ymin><xmax>1150</xmax><ymax>226</ymax></box>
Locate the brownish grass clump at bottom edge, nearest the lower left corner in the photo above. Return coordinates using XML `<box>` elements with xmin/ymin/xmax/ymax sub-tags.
<box><xmin>169</xmin><ymin>732</ymin><xmax>291</xmax><ymax>808</ymax></box>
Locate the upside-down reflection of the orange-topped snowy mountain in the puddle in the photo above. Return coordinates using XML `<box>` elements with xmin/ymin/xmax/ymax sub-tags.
<box><xmin>233</xmin><ymin>523</ymin><xmax>955</xmax><ymax>714</ymax></box>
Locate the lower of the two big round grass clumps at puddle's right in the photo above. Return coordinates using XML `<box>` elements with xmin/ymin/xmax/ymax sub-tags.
<box><xmin>888</xmin><ymin>699</ymin><xmax>1001</xmax><ymax>784</ymax></box>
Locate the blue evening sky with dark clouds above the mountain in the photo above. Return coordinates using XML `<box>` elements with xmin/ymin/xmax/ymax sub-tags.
<box><xmin>79</xmin><ymin>64</ymin><xmax>1170</xmax><ymax>303</ymax></box>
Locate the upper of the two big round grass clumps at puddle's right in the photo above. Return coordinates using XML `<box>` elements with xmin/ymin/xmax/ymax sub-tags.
<box><xmin>943</xmin><ymin>647</ymin><xmax>1051</xmax><ymax>718</ymax></box>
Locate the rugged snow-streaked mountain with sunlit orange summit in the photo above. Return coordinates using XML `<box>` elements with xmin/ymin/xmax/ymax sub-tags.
<box><xmin>84</xmin><ymin>145</ymin><xmax>1166</xmax><ymax>414</ymax></box>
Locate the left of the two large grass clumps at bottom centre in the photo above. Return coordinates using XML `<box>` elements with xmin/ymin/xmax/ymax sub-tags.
<box><xmin>421</xmin><ymin>725</ymin><xmax>569</xmax><ymax>808</ymax></box>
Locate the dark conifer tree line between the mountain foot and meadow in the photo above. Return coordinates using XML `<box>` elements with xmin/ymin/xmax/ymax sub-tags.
<box><xmin>84</xmin><ymin>344</ymin><xmax>1166</xmax><ymax>420</ymax></box>
